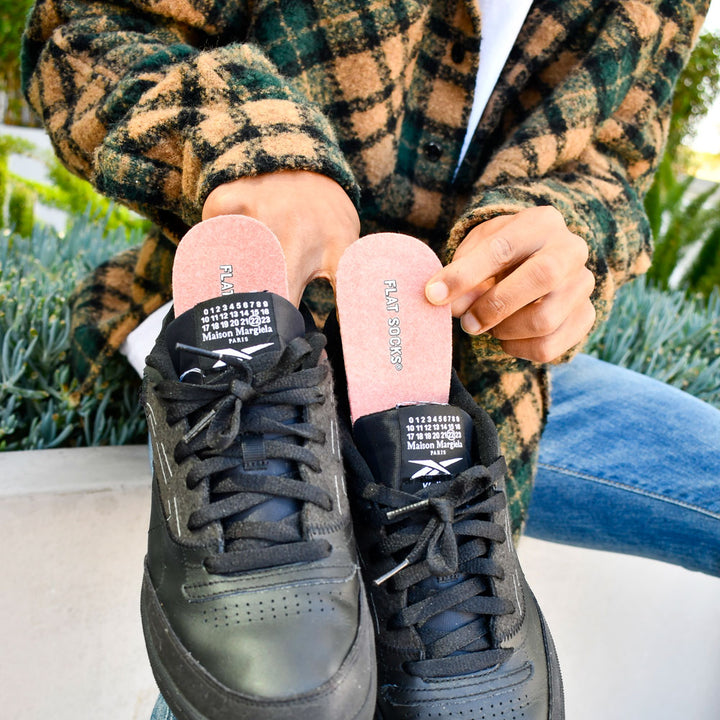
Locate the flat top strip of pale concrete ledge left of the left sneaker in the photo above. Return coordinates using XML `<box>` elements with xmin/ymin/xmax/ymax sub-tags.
<box><xmin>0</xmin><ymin>445</ymin><xmax>150</xmax><ymax>497</ymax></box>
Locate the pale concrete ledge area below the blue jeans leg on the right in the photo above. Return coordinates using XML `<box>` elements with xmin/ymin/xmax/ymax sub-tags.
<box><xmin>519</xmin><ymin>537</ymin><xmax>720</xmax><ymax>720</ymax></box>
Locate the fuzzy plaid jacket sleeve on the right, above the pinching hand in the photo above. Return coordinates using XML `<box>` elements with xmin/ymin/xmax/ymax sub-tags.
<box><xmin>449</xmin><ymin>0</ymin><xmax>708</xmax><ymax>358</ymax></box>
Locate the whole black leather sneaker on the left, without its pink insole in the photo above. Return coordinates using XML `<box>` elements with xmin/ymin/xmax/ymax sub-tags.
<box><xmin>142</xmin><ymin>293</ymin><xmax>375</xmax><ymax>720</ymax></box>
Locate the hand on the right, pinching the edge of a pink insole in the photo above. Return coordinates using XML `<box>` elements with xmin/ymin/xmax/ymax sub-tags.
<box><xmin>425</xmin><ymin>207</ymin><xmax>595</xmax><ymax>362</ymax></box>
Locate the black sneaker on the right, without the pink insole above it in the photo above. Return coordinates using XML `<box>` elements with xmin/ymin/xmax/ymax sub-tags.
<box><xmin>343</xmin><ymin>379</ymin><xmax>564</xmax><ymax>720</ymax></box>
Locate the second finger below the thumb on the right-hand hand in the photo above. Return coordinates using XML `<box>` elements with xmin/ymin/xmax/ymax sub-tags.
<box><xmin>492</xmin><ymin>268</ymin><xmax>595</xmax><ymax>340</ymax></box>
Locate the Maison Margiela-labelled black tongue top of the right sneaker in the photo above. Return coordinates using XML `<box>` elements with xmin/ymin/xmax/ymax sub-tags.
<box><xmin>353</xmin><ymin>403</ymin><xmax>474</xmax><ymax>493</ymax></box>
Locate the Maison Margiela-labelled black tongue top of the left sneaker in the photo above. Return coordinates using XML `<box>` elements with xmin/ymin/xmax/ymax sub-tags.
<box><xmin>166</xmin><ymin>292</ymin><xmax>305</xmax><ymax>383</ymax></box>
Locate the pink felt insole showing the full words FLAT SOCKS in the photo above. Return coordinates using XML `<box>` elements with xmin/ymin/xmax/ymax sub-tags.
<box><xmin>336</xmin><ymin>233</ymin><xmax>452</xmax><ymax>421</ymax></box>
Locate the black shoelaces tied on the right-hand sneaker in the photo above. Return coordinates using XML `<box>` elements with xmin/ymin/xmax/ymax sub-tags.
<box><xmin>362</xmin><ymin>458</ymin><xmax>514</xmax><ymax>678</ymax></box>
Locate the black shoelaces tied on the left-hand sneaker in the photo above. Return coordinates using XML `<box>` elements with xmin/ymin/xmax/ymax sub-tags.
<box><xmin>157</xmin><ymin>333</ymin><xmax>332</xmax><ymax>574</ymax></box>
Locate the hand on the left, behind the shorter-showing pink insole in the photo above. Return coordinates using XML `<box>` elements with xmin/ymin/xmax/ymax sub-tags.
<box><xmin>202</xmin><ymin>170</ymin><xmax>360</xmax><ymax>305</ymax></box>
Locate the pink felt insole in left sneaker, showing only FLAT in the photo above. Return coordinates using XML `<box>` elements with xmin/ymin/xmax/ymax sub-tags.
<box><xmin>172</xmin><ymin>215</ymin><xmax>289</xmax><ymax>315</ymax></box>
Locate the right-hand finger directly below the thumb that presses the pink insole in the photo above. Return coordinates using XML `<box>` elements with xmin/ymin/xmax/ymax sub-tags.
<box><xmin>461</xmin><ymin>252</ymin><xmax>570</xmax><ymax>334</ymax></box>
